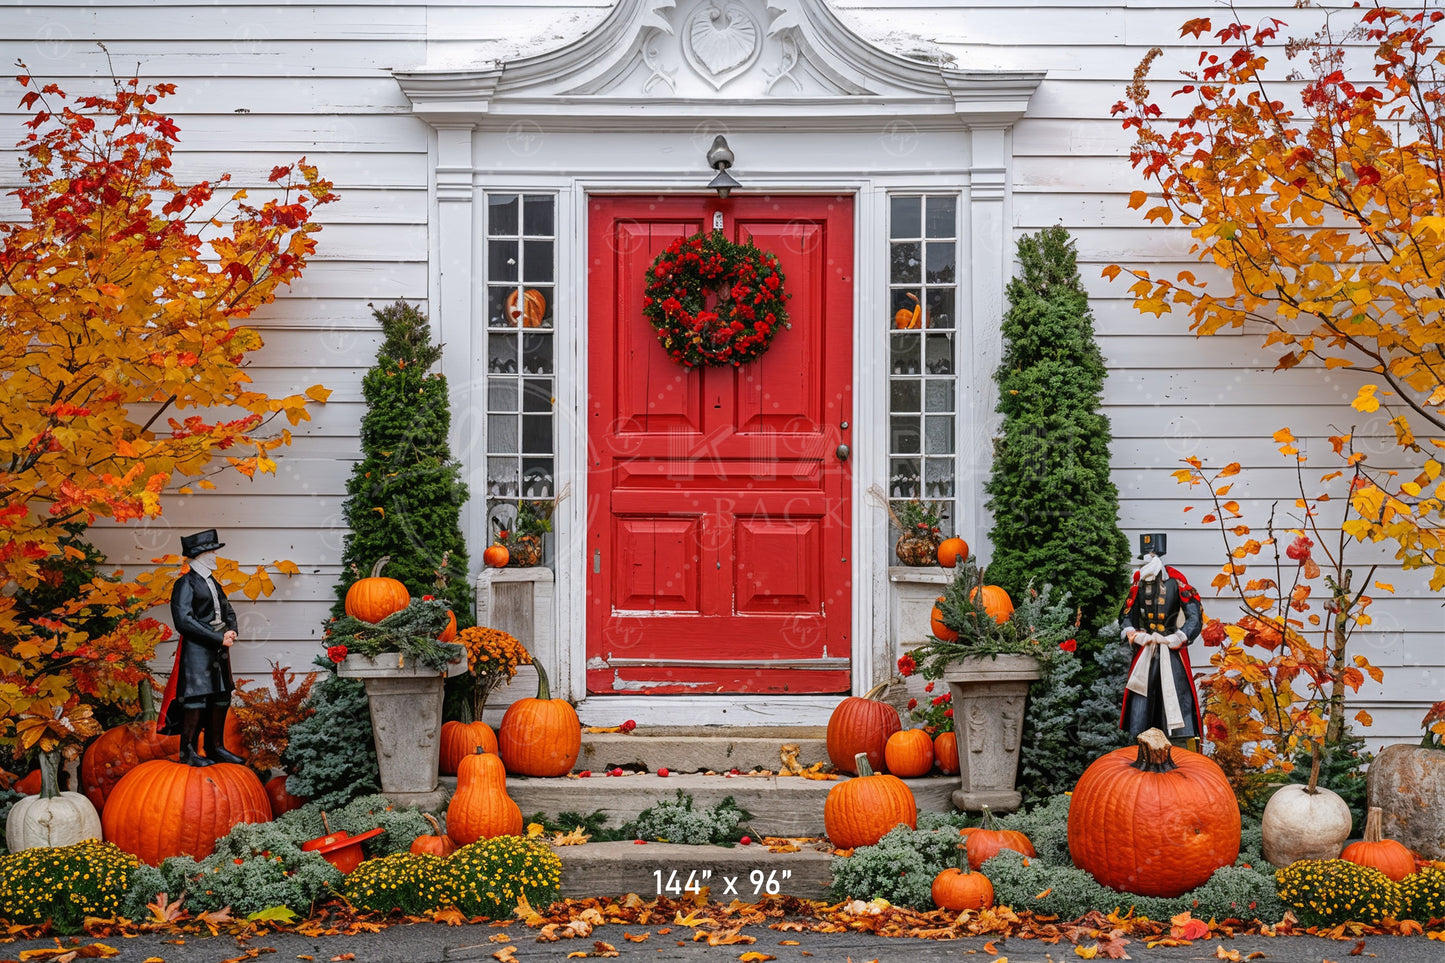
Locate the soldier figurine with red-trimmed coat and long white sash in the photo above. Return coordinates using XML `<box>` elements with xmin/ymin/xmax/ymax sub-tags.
<box><xmin>1118</xmin><ymin>534</ymin><xmax>1204</xmax><ymax>740</ymax></box>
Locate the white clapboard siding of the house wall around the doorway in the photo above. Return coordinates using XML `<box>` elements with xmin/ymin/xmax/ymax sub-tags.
<box><xmin>0</xmin><ymin>0</ymin><xmax>1445</xmax><ymax>745</ymax></box>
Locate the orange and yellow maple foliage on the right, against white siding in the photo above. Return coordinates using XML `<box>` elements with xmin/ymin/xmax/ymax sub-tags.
<box><xmin>1104</xmin><ymin>6</ymin><xmax>1445</xmax><ymax>591</ymax></box>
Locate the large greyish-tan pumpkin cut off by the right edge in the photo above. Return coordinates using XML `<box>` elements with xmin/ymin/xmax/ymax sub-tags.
<box><xmin>1366</xmin><ymin>743</ymin><xmax>1445</xmax><ymax>859</ymax></box>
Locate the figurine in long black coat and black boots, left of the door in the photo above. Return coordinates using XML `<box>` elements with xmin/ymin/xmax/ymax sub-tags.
<box><xmin>160</xmin><ymin>528</ymin><xmax>246</xmax><ymax>766</ymax></box>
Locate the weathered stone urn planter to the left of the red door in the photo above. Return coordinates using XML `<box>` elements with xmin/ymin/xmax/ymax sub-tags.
<box><xmin>337</xmin><ymin>646</ymin><xmax>467</xmax><ymax>810</ymax></box>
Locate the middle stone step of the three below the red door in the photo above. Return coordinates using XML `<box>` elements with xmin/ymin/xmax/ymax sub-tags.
<box><xmin>491</xmin><ymin>772</ymin><xmax>958</xmax><ymax>837</ymax></box>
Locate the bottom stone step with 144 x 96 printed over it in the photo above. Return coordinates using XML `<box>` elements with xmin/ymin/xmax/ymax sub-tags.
<box><xmin>555</xmin><ymin>842</ymin><xmax>832</xmax><ymax>904</ymax></box>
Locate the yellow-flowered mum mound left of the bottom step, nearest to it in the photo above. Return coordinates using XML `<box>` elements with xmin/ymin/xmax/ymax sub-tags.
<box><xmin>439</xmin><ymin>836</ymin><xmax>562</xmax><ymax>920</ymax></box>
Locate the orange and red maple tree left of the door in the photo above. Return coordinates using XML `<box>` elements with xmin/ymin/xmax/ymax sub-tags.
<box><xmin>0</xmin><ymin>64</ymin><xmax>335</xmax><ymax>752</ymax></box>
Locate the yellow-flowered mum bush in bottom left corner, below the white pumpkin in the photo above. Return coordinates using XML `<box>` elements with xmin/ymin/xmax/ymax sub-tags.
<box><xmin>0</xmin><ymin>840</ymin><xmax>140</xmax><ymax>933</ymax></box>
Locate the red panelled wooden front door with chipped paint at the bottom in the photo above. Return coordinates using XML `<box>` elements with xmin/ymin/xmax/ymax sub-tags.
<box><xmin>585</xmin><ymin>195</ymin><xmax>854</xmax><ymax>694</ymax></box>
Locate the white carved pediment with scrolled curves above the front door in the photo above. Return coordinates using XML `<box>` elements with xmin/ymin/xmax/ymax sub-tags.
<box><xmin>396</xmin><ymin>0</ymin><xmax>1043</xmax><ymax>123</ymax></box>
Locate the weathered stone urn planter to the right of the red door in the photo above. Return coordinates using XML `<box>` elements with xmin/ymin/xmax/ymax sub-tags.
<box><xmin>944</xmin><ymin>655</ymin><xmax>1042</xmax><ymax>813</ymax></box>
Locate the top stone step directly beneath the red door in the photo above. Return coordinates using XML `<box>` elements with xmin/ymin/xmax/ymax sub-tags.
<box><xmin>577</xmin><ymin>726</ymin><xmax>828</xmax><ymax>772</ymax></box>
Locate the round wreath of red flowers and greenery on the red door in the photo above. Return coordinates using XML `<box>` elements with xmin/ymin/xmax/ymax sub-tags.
<box><xmin>642</xmin><ymin>231</ymin><xmax>790</xmax><ymax>367</ymax></box>
